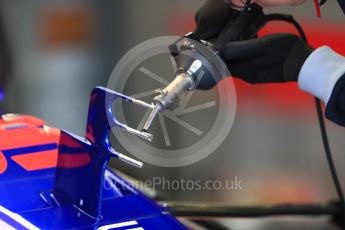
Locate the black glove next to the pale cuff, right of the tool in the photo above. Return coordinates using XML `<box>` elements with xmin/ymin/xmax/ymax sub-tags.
<box><xmin>220</xmin><ymin>34</ymin><xmax>313</xmax><ymax>83</ymax></box>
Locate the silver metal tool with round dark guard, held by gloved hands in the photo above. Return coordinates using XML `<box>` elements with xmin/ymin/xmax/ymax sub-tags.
<box><xmin>142</xmin><ymin>33</ymin><xmax>228</xmax><ymax>132</ymax></box>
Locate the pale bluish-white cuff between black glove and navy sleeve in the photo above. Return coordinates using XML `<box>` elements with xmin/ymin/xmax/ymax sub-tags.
<box><xmin>298</xmin><ymin>46</ymin><xmax>345</xmax><ymax>104</ymax></box>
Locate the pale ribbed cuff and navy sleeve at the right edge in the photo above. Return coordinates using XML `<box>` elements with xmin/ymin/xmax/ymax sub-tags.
<box><xmin>298</xmin><ymin>46</ymin><xmax>345</xmax><ymax>126</ymax></box>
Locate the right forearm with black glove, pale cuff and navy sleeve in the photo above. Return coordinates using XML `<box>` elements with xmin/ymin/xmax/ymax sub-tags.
<box><xmin>221</xmin><ymin>34</ymin><xmax>345</xmax><ymax>126</ymax></box>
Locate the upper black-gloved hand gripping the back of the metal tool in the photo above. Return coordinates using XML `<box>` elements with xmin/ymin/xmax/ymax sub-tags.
<box><xmin>194</xmin><ymin>0</ymin><xmax>265</xmax><ymax>89</ymax></box>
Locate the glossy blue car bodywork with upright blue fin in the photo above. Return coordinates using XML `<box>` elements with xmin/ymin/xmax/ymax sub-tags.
<box><xmin>0</xmin><ymin>87</ymin><xmax>186</xmax><ymax>229</ymax></box>
